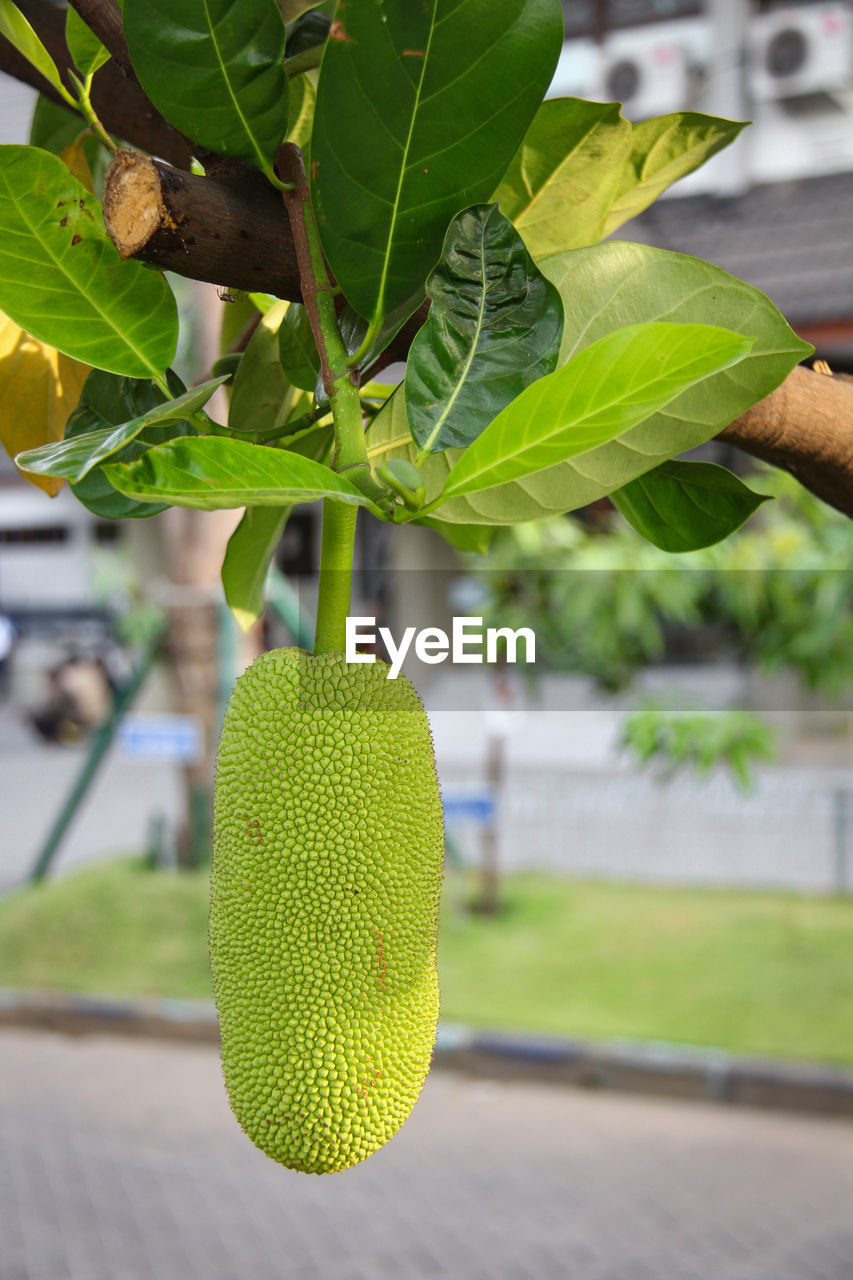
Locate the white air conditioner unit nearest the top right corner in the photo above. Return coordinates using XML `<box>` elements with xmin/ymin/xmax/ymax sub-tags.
<box><xmin>751</xmin><ymin>4</ymin><xmax>853</xmax><ymax>101</ymax></box>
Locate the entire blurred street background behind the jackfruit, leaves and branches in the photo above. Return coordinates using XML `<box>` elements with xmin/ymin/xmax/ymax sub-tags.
<box><xmin>0</xmin><ymin>0</ymin><xmax>853</xmax><ymax>1280</ymax></box>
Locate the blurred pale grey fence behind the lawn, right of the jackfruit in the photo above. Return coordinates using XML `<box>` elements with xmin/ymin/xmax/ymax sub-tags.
<box><xmin>442</xmin><ymin>765</ymin><xmax>853</xmax><ymax>893</ymax></box>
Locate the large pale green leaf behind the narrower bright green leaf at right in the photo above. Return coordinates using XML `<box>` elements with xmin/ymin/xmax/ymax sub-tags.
<box><xmin>368</xmin><ymin>242</ymin><xmax>812</xmax><ymax>525</ymax></box>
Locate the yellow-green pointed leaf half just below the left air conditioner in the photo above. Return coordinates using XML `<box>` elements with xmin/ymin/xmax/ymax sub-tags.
<box><xmin>604</xmin><ymin>111</ymin><xmax>747</xmax><ymax>239</ymax></box>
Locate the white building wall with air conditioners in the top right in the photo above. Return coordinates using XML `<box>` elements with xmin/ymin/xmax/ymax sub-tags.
<box><xmin>551</xmin><ymin>0</ymin><xmax>853</xmax><ymax>186</ymax></box>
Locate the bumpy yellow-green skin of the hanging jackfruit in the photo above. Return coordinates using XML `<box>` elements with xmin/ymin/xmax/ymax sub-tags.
<box><xmin>210</xmin><ymin>649</ymin><xmax>444</xmax><ymax>1174</ymax></box>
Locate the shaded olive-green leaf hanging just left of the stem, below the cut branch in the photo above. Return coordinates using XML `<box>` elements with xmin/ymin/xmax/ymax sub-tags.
<box><xmin>228</xmin><ymin>302</ymin><xmax>302</xmax><ymax>433</ymax></box>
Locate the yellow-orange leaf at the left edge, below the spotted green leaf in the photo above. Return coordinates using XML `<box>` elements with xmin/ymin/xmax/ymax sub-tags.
<box><xmin>0</xmin><ymin>311</ymin><xmax>90</xmax><ymax>498</ymax></box>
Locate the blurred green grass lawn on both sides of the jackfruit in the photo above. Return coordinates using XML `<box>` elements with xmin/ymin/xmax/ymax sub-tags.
<box><xmin>0</xmin><ymin>863</ymin><xmax>853</xmax><ymax>1064</ymax></box>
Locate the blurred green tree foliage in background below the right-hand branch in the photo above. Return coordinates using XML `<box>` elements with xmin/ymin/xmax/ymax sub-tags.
<box><xmin>469</xmin><ymin>468</ymin><xmax>853</xmax><ymax>695</ymax></box>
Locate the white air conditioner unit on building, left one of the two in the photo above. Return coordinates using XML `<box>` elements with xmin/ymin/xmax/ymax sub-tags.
<box><xmin>596</xmin><ymin>40</ymin><xmax>689</xmax><ymax>120</ymax></box>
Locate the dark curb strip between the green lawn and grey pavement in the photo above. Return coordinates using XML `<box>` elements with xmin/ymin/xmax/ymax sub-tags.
<box><xmin>0</xmin><ymin>988</ymin><xmax>853</xmax><ymax>1116</ymax></box>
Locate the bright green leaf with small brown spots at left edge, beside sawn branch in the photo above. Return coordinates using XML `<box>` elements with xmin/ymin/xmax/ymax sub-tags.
<box><xmin>0</xmin><ymin>146</ymin><xmax>178</xmax><ymax>378</ymax></box>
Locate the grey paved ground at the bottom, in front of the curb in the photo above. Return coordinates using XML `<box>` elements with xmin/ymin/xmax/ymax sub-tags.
<box><xmin>0</xmin><ymin>1030</ymin><xmax>853</xmax><ymax>1280</ymax></box>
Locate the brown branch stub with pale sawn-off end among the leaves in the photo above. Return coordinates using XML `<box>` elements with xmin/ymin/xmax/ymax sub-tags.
<box><xmin>104</xmin><ymin>148</ymin><xmax>300</xmax><ymax>301</ymax></box>
